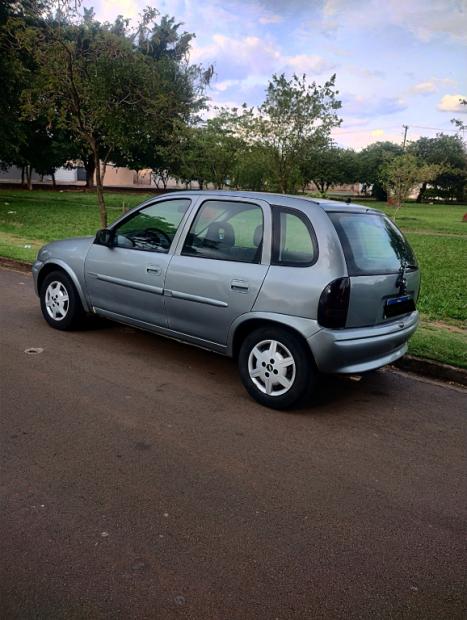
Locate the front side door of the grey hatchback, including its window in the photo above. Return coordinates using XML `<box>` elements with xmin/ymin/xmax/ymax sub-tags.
<box><xmin>85</xmin><ymin>198</ymin><xmax>191</xmax><ymax>327</ymax></box>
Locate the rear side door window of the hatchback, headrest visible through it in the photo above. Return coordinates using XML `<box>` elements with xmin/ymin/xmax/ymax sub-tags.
<box><xmin>182</xmin><ymin>200</ymin><xmax>263</xmax><ymax>263</ymax></box>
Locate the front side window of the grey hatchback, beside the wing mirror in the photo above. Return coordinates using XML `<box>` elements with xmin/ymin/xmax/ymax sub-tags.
<box><xmin>114</xmin><ymin>198</ymin><xmax>191</xmax><ymax>253</ymax></box>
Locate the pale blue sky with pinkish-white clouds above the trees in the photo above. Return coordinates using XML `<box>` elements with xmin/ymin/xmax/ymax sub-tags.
<box><xmin>83</xmin><ymin>0</ymin><xmax>467</xmax><ymax>149</ymax></box>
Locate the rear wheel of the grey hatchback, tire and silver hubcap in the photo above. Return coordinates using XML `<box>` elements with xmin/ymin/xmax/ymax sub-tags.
<box><xmin>238</xmin><ymin>327</ymin><xmax>316</xmax><ymax>409</ymax></box>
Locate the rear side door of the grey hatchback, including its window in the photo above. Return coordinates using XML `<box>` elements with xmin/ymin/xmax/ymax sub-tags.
<box><xmin>165</xmin><ymin>199</ymin><xmax>270</xmax><ymax>345</ymax></box>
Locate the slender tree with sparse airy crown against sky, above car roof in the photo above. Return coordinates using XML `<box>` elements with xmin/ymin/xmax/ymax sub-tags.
<box><xmin>243</xmin><ymin>74</ymin><xmax>341</xmax><ymax>193</ymax></box>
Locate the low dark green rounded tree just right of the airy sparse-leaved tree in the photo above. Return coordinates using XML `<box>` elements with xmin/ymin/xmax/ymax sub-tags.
<box><xmin>302</xmin><ymin>146</ymin><xmax>359</xmax><ymax>196</ymax></box>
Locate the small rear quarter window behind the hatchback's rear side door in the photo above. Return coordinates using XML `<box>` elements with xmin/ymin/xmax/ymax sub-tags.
<box><xmin>272</xmin><ymin>207</ymin><xmax>318</xmax><ymax>267</ymax></box>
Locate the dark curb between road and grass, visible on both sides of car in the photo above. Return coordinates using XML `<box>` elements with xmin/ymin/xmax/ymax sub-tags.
<box><xmin>0</xmin><ymin>256</ymin><xmax>467</xmax><ymax>387</ymax></box>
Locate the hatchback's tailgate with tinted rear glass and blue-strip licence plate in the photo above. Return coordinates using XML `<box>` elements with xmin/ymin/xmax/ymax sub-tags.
<box><xmin>328</xmin><ymin>211</ymin><xmax>420</xmax><ymax>327</ymax></box>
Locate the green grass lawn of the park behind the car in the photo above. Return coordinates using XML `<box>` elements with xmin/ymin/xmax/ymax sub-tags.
<box><xmin>0</xmin><ymin>189</ymin><xmax>467</xmax><ymax>368</ymax></box>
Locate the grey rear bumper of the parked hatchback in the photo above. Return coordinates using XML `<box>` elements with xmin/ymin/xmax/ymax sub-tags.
<box><xmin>308</xmin><ymin>312</ymin><xmax>419</xmax><ymax>374</ymax></box>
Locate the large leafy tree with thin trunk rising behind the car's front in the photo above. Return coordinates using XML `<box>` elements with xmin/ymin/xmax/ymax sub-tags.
<box><xmin>23</xmin><ymin>9</ymin><xmax>210</xmax><ymax>227</ymax></box>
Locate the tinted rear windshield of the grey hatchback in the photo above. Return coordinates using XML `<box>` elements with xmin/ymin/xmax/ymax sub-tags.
<box><xmin>329</xmin><ymin>212</ymin><xmax>417</xmax><ymax>276</ymax></box>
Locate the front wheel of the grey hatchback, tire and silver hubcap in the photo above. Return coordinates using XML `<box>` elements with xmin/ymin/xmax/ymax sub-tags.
<box><xmin>39</xmin><ymin>271</ymin><xmax>85</xmax><ymax>331</ymax></box>
